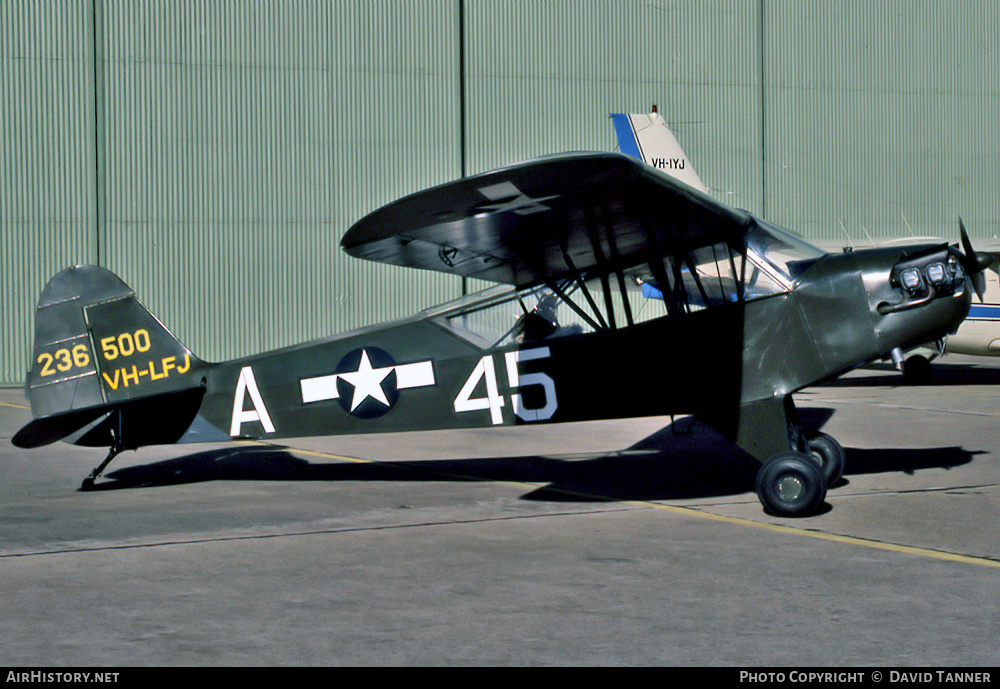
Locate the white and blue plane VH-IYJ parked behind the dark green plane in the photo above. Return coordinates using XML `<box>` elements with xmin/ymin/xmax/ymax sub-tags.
<box><xmin>611</xmin><ymin>105</ymin><xmax>1000</xmax><ymax>382</ymax></box>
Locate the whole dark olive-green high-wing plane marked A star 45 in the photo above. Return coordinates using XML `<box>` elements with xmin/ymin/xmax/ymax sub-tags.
<box><xmin>13</xmin><ymin>144</ymin><xmax>982</xmax><ymax>516</ymax></box>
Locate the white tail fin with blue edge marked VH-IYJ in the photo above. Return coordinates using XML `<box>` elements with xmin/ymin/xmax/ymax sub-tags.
<box><xmin>611</xmin><ymin>105</ymin><xmax>708</xmax><ymax>192</ymax></box>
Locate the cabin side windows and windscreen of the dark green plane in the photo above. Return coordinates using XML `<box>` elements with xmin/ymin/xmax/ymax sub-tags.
<box><xmin>424</xmin><ymin>220</ymin><xmax>823</xmax><ymax>349</ymax></box>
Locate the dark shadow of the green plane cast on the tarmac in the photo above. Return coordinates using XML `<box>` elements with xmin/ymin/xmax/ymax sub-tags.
<box><xmin>91</xmin><ymin>409</ymin><xmax>978</xmax><ymax>502</ymax></box>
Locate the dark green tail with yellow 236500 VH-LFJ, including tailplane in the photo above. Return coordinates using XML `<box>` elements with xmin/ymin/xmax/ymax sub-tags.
<box><xmin>11</xmin><ymin>266</ymin><xmax>205</xmax><ymax>449</ymax></box>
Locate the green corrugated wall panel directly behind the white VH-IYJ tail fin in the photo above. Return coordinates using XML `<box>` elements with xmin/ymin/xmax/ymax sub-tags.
<box><xmin>466</xmin><ymin>0</ymin><xmax>760</xmax><ymax>214</ymax></box>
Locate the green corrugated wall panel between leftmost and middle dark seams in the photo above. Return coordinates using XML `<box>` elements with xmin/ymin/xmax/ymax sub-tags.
<box><xmin>103</xmin><ymin>0</ymin><xmax>460</xmax><ymax>359</ymax></box>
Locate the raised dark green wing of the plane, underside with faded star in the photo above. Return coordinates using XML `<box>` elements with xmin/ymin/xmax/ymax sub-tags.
<box><xmin>341</xmin><ymin>153</ymin><xmax>751</xmax><ymax>287</ymax></box>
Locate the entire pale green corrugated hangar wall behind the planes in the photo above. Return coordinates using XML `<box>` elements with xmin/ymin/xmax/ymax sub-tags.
<box><xmin>0</xmin><ymin>0</ymin><xmax>1000</xmax><ymax>385</ymax></box>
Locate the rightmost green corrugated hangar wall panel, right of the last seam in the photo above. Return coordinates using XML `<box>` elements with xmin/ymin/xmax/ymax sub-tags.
<box><xmin>764</xmin><ymin>0</ymin><xmax>1000</xmax><ymax>243</ymax></box>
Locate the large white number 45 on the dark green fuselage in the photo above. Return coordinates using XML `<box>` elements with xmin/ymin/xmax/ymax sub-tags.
<box><xmin>455</xmin><ymin>347</ymin><xmax>559</xmax><ymax>425</ymax></box>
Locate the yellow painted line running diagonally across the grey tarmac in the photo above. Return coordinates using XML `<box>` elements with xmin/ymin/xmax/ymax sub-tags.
<box><xmin>278</xmin><ymin>440</ymin><xmax>1000</xmax><ymax>569</ymax></box>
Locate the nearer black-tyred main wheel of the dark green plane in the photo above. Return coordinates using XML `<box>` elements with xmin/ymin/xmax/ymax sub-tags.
<box><xmin>757</xmin><ymin>451</ymin><xmax>826</xmax><ymax>517</ymax></box>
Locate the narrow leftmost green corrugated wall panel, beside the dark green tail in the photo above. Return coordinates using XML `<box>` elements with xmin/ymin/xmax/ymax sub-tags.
<box><xmin>0</xmin><ymin>0</ymin><xmax>96</xmax><ymax>384</ymax></box>
